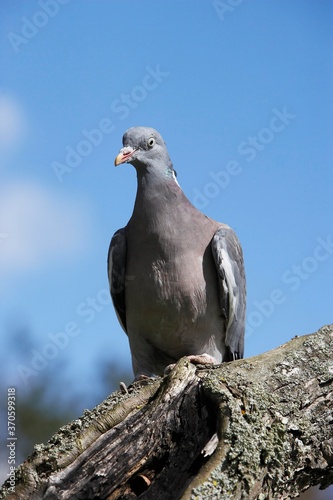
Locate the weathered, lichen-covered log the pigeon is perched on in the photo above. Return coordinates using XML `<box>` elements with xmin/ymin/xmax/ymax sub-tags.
<box><xmin>0</xmin><ymin>325</ymin><xmax>333</xmax><ymax>500</ymax></box>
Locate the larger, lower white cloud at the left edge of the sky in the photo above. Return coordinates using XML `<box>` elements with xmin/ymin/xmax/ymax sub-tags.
<box><xmin>0</xmin><ymin>183</ymin><xmax>89</xmax><ymax>271</ymax></box>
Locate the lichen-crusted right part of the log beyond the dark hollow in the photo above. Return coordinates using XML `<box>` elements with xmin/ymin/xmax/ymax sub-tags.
<box><xmin>184</xmin><ymin>327</ymin><xmax>333</xmax><ymax>499</ymax></box>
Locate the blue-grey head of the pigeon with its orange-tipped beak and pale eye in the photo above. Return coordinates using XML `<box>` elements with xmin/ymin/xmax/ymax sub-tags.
<box><xmin>114</xmin><ymin>127</ymin><xmax>173</xmax><ymax>172</ymax></box>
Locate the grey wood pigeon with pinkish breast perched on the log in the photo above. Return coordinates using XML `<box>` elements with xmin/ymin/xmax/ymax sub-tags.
<box><xmin>108</xmin><ymin>127</ymin><xmax>246</xmax><ymax>378</ymax></box>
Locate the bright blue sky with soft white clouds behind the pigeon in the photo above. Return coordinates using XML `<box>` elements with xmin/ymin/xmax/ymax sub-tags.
<box><xmin>0</xmin><ymin>0</ymin><xmax>333</xmax><ymax>418</ymax></box>
